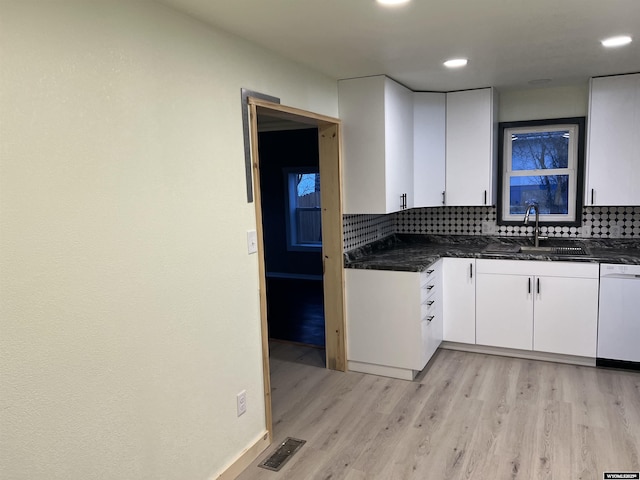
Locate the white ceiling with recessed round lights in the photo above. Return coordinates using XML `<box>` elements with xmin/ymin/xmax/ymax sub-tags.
<box><xmin>160</xmin><ymin>0</ymin><xmax>640</xmax><ymax>91</ymax></box>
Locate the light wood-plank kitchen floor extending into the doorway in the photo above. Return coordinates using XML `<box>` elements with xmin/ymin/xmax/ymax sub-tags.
<box><xmin>238</xmin><ymin>344</ymin><xmax>640</xmax><ymax>480</ymax></box>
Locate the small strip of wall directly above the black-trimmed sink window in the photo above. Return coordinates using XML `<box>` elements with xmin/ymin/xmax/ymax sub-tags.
<box><xmin>499</xmin><ymin>84</ymin><xmax>589</xmax><ymax>122</ymax></box>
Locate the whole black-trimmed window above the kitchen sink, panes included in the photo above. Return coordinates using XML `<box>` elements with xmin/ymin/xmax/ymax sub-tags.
<box><xmin>498</xmin><ymin>118</ymin><xmax>584</xmax><ymax>226</ymax></box>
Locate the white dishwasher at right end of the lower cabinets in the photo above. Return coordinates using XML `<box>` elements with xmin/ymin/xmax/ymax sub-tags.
<box><xmin>596</xmin><ymin>263</ymin><xmax>640</xmax><ymax>370</ymax></box>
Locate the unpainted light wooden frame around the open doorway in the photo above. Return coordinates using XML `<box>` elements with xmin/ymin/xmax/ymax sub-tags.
<box><xmin>248</xmin><ymin>97</ymin><xmax>347</xmax><ymax>441</ymax></box>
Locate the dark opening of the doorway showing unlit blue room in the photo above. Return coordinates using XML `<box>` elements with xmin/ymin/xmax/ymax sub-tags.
<box><xmin>256</xmin><ymin>125</ymin><xmax>325</xmax><ymax>350</ymax></box>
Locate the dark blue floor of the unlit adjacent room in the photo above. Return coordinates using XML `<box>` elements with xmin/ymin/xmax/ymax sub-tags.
<box><xmin>267</xmin><ymin>277</ymin><xmax>325</xmax><ymax>347</ymax></box>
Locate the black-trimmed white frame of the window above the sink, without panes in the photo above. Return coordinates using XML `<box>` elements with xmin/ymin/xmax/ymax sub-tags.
<box><xmin>496</xmin><ymin>117</ymin><xmax>586</xmax><ymax>227</ymax></box>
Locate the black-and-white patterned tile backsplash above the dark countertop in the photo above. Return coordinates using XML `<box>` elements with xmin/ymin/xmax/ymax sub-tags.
<box><xmin>343</xmin><ymin>206</ymin><xmax>640</xmax><ymax>251</ymax></box>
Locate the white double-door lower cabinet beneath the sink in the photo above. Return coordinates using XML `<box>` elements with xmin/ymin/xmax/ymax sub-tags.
<box><xmin>476</xmin><ymin>260</ymin><xmax>599</xmax><ymax>357</ymax></box>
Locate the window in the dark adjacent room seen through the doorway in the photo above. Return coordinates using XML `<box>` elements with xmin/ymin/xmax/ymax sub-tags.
<box><xmin>285</xmin><ymin>168</ymin><xmax>322</xmax><ymax>251</ymax></box>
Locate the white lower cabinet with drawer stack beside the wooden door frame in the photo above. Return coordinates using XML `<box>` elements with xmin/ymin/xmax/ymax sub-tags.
<box><xmin>345</xmin><ymin>262</ymin><xmax>442</xmax><ymax>380</ymax></box>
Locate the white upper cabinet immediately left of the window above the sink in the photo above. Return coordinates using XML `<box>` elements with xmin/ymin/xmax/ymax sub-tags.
<box><xmin>445</xmin><ymin>88</ymin><xmax>498</xmax><ymax>206</ymax></box>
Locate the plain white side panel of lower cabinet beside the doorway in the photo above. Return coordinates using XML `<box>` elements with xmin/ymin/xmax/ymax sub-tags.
<box><xmin>345</xmin><ymin>269</ymin><xmax>424</xmax><ymax>370</ymax></box>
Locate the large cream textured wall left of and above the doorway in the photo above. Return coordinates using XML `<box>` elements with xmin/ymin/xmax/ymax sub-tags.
<box><xmin>0</xmin><ymin>0</ymin><xmax>338</xmax><ymax>480</ymax></box>
